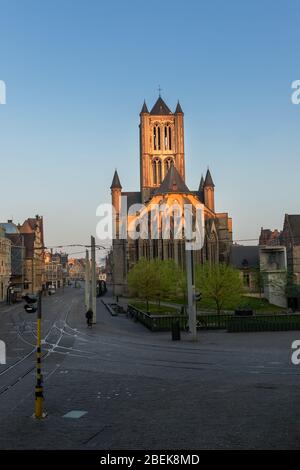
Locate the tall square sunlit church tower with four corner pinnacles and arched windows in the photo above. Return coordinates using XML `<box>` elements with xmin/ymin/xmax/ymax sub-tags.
<box><xmin>140</xmin><ymin>95</ymin><xmax>185</xmax><ymax>202</ymax></box>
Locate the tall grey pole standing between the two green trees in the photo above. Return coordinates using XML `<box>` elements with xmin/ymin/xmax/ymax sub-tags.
<box><xmin>185</xmin><ymin>242</ymin><xmax>197</xmax><ymax>341</ymax></box>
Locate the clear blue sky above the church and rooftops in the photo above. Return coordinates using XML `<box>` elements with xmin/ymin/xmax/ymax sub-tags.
<box><xmin>0</xmin><ymin>0</ymin><xmax>300</xmax><ymax>253</ymax></box>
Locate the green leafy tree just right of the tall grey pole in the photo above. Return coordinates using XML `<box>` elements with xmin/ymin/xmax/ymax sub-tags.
<box><xmin>196</xmin><ymin>264</ymin><xmax>243</xmax><ymax>313</ymax></box>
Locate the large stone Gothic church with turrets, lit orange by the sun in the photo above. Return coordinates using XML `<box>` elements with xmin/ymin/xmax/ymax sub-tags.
<box><xmin>110</xmin><ymin>95</ymin><xmax>232</xmax><ymax>295</ymax></box>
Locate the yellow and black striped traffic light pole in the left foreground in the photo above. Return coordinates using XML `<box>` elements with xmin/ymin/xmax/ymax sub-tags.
<box><xmin>34</xmin><ymin>291</ymin><xmax>45</xmax><ymax>419</ymax></box>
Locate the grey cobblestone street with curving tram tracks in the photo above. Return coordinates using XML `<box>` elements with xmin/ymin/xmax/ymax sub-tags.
<box><xmin>0</xmin><ymin>289</ymin><xmax>300</xmax><ymax>449</ymax></box>
